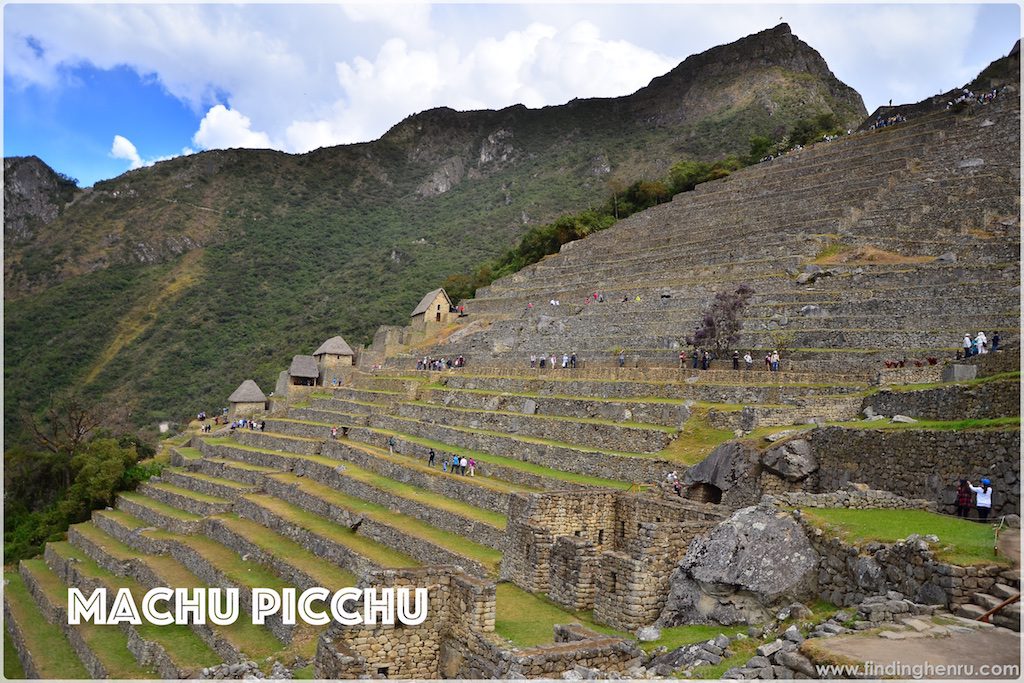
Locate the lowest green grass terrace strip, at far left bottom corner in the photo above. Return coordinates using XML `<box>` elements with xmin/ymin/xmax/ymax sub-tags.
<box><xmin>3</xmin><ymin>567</ymin><xmax>92</xmax><ymax>679</ymax></box>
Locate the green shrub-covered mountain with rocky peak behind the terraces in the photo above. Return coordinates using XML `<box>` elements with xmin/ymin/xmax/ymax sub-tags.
<box><xmin>4</xmin><ymin>25</ymin><xmax>865</xmax><ymax>433</ymax></box>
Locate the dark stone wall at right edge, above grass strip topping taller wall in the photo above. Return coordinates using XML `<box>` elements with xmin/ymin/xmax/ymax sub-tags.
<box><xmin>862</xmin><ymin>380</ymin><xmax>1021</xmax><ymax>420</ymax></box>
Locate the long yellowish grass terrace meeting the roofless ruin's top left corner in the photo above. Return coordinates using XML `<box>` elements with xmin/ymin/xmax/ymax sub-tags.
<box><xmin>192</xmin><ymin>438</ymin><xmax>505</xmax><ymax>549</ymax></box>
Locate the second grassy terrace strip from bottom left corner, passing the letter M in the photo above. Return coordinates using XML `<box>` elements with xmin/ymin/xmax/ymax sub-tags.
<box><xmin>18</xmin><ymin>559</ymin><xmax>156</xmax><ymax>679</ymax></box>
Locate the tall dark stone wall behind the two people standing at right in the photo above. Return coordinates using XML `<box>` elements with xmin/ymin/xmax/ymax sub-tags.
<box><xmin>809</xmin><ymin>427</ymin><xmax>1020</xmax><ymax>515</ymax></box>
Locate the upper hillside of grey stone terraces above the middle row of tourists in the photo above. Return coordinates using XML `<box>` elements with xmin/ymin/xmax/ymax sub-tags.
<box><xmin>411</xmin><ymin>97</ymin><xmax>1020</xmax><ymax>368</ymax></box>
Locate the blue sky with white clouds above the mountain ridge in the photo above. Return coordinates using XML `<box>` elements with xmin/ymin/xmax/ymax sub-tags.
<box><xmin>3</xmin><ymin>2</ymin><xmax>1021</xmax><ymax>185</ymax></box>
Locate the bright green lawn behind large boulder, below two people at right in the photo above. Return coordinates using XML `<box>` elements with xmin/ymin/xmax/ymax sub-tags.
<box><xmin>801</xmin><ymin>508</ymin><xmax>1009</xmax><ymax>565</ymax></box>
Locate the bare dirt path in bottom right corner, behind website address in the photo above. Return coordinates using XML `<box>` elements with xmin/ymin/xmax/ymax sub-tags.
<box><xmin>821</xmin><ymin>629</ymin><xmax>1021</xmax><ymax>679</ymax></box>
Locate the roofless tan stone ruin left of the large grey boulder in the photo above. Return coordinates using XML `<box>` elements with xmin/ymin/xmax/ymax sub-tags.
<box><xmin>501</xmin><ymin>490</ymin><xmax>725</xmax><ymax>630</ymax></box>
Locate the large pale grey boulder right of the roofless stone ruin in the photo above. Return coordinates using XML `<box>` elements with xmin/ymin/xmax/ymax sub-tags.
<box><xmin>657</xmin><ymin>506</ymin><xmax>819</xmax><ymax>628</ymax></box>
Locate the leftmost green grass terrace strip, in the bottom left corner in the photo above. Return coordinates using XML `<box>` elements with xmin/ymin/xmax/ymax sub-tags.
<box><xmin>3</xmin><ymin>568</ymin><xmax>91</xmax><ymax>678</ymax></box>
